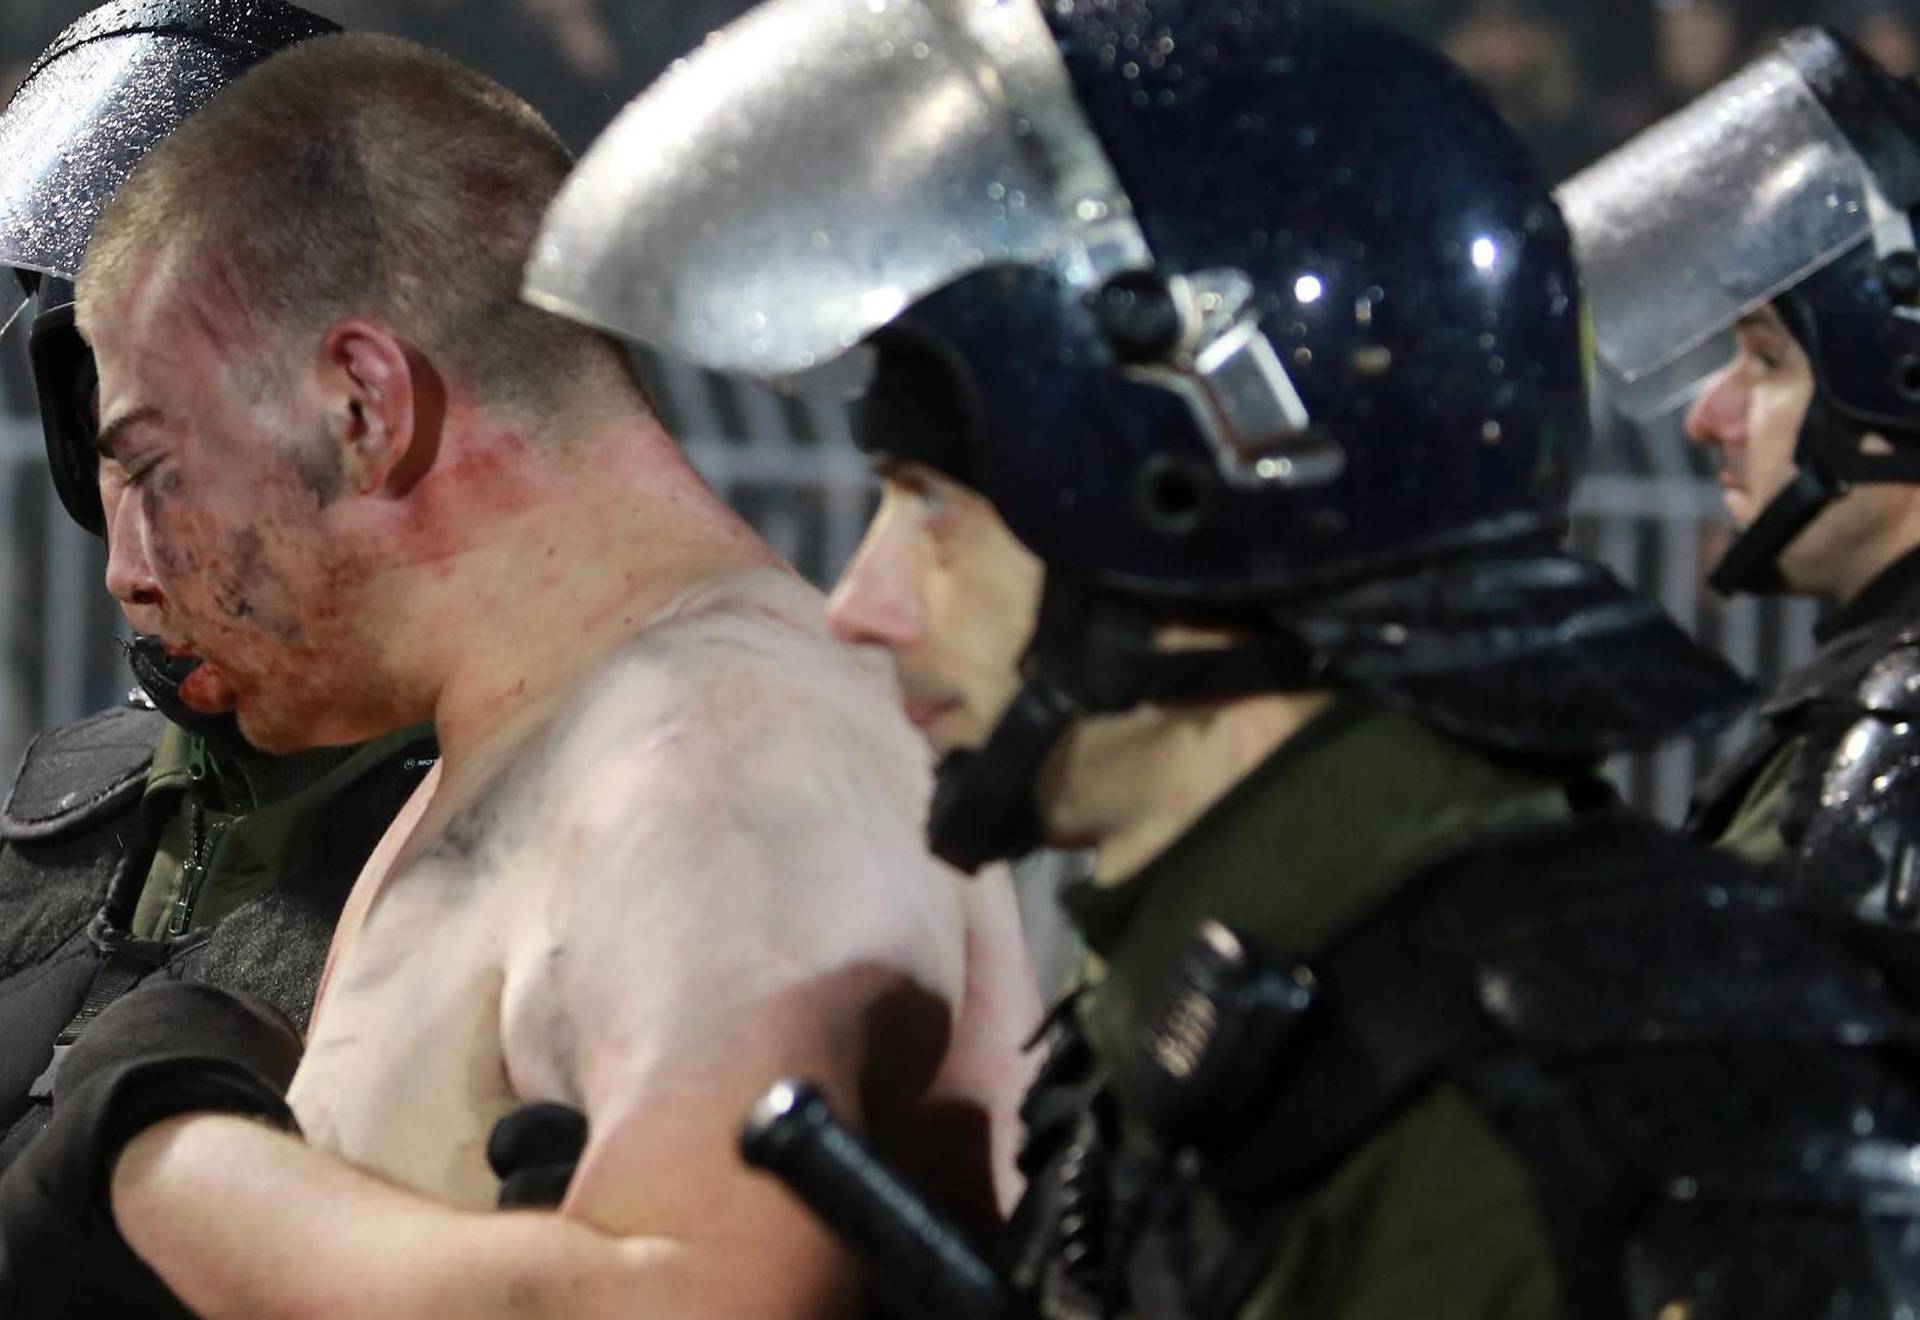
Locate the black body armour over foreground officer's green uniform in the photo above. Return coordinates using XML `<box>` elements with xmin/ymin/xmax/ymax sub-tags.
<box><xmin>1008</xmin><ymin>813</ymin><xmax>1920</xmax><ymax>1320</ymax></box>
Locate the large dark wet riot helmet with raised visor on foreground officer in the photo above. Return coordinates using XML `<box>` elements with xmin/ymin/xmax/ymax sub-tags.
<box><xmin>528</xmin><ymin>0</ymin><xmax>1740</xmax><ymax>865</ymax></box>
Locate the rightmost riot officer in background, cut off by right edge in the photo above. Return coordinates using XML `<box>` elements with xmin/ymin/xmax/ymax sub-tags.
<box><xmin>1559</xmin><ymin>29</ymin><xmax>1920</xmax><ymax>931</ymax></box>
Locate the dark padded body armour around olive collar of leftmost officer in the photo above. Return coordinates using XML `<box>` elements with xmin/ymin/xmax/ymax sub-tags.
<box><xmin>0</xmin><ymin>706</ymin><xmax>432</xmax><ymax>1168</ymax></box>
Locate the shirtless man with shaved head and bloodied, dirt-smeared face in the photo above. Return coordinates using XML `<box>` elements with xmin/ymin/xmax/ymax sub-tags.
<box><xmin>0</xmin><ymin>36</ymin><xmax>1037</xmax><ymax>1320</ymax></box>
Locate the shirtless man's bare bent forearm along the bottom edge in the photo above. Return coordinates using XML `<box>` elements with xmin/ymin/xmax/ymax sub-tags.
<box><xmin>113</xmin><ymin>1115</ymin><xmax>837</xmax><ymax>1320</ymax></box>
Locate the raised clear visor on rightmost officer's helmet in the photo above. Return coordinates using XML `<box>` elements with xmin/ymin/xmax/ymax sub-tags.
<box><xmin>1557</xmin><ymin>54</ymin><xmax>1874</xmax><ymax>418</ymax></box>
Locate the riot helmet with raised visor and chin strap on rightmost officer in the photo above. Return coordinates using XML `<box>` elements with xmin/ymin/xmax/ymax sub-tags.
<box><xmin>1559</xmin><ymin>29</ymin><xmax>1920</xmax><ymax>593</ymax></box>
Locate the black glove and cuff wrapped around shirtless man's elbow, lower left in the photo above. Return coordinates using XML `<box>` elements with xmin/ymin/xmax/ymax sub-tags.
<box><xmin>0</xmin><ymin>980</ymin><xmax>300</xmax><ymax>1320</ymax></box>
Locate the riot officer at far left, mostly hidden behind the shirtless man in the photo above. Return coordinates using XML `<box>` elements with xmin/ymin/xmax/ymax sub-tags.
<box><xmin>0</xmin><ymin>0</ymin><xmax>434</xmax><ymax>1167</ymax></box>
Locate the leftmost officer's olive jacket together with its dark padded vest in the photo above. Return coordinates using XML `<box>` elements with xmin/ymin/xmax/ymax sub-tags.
<box><xmin>0</xmin><ymin>706</ymin><xmax>436</xmax><ymax>1168</ymax></box>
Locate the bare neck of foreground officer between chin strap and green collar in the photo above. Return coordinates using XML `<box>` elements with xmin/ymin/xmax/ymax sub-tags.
<box><xmin>1069</xmin><ymin>693</ymin><xmax>1332</xmax><ymax>883</ymax></box>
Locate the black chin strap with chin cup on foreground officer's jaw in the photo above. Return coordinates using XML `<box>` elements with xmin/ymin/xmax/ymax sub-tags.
<box><xmin>927</xmin><ymin>570</ymin><xmax>1327</xmax><ymax>873</ymax></box>
